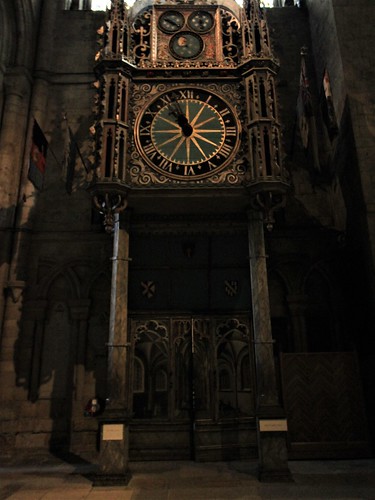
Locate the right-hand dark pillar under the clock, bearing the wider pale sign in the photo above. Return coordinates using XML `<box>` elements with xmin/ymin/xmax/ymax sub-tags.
<box><xmin>248</xmin><ymin>210</ymin><xmax>291</xmax><ymax>481</ymax></box>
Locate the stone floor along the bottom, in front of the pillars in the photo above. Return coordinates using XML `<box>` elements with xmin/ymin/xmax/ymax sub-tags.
<box><xmin>0</xmin><ymin>458</ymin><xmax>375</xmax><ymax>500</ymax></box>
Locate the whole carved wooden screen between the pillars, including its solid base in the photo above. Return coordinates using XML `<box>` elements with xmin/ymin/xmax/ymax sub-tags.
<box><xmin>129</xmin><ymin>315</ymin><xmax>256</xmax><ymax>461</ymax></box>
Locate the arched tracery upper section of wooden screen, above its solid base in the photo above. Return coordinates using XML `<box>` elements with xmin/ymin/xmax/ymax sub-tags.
<box><xmin>131</xmin><ymin>317</ymin><xmax>254</xmax><ymax>420</ymax></box>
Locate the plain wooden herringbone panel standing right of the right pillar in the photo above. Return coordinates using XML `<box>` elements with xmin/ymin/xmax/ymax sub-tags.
<box><xmin>281</xmin><ymin>352</ymin><xmax>369</xmax><ymax>458</ymax></box>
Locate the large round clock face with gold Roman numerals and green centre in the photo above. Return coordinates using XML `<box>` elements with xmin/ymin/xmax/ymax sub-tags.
<box><xmin>135</xmin><ymin>87</ymin><xmax>239</xmax><ymax>180</ymax></box>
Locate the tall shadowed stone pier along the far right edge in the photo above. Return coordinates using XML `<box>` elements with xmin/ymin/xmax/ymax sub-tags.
<box><xmin>306</xmin><ymin>0</ymin><xmax>375</xmax><ymax>450</ymax></box>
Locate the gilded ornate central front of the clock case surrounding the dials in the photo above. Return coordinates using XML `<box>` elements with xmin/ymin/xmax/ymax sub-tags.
<box><xmin>127</xmin><ymin>4</ymin><xmax>247</xmax><ymax>188</ymax></box>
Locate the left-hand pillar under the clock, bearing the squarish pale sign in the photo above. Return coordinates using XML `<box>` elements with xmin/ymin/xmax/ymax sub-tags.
<box><xmin>94</xmin><ymin>214</ymin><xmax>131</xmax><ymax>486</ymax></box>
